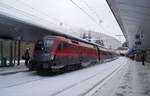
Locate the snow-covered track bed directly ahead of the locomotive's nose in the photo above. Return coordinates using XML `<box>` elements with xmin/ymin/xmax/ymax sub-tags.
<box><xmin>0</xmin><ymin>70</ymin><xmax>46</xmax><ymax>88</ymax></box>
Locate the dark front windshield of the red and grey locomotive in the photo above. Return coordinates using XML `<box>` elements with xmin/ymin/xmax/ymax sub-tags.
<box><xmin>35</xmin><ymin>39</ymin><xmax>54</xmax><ymax>53</ymax></box>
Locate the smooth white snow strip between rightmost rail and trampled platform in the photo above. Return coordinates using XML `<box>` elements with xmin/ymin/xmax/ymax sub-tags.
<box><xmin>86</xmin><ymin>58</ymin><xmax>128</xmax><ymax>96</ymax></box>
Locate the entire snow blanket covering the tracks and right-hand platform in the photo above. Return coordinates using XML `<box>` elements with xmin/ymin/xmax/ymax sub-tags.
<box><xmin>0</xmin><ymin>57</ymin><xmax>150</xmax><ymax>96</ymax></box>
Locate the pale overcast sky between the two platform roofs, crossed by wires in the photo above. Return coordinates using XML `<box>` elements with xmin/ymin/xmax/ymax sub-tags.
<box><xmin>0</xmin><ymin>0</ymin><xmax>124</xmax><ymax>41</ymax></box>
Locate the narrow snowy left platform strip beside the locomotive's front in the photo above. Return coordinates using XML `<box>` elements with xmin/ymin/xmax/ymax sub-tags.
<box><xmin>0</xmin><ymin>60</ymin><xmax>28</xmax><ymax>74</ymax></box>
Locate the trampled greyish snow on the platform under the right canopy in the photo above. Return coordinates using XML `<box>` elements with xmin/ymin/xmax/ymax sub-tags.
<box><xmin>113</xmin><ymin>60</ymin><xmax>150</xmax><ymax>96</ymax></box>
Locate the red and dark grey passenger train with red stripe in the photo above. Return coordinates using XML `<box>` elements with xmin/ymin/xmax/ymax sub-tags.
<box><xmin>28</xmin><ymin>36</ymin><xmax>117</xmax><ymax>74</ymax></box>
